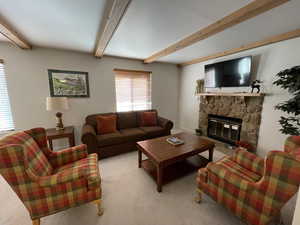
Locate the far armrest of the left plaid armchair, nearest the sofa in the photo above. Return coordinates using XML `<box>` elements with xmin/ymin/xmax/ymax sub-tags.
<box><xmin>49</xmin><ymin>144</ymin><xmax>88</xmax><ymax>167</ymax></box>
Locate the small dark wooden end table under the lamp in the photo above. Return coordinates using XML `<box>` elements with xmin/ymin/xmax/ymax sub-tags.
<box><xmin>46</xmin><ymin>126</ymin><xmax>75</xmax><ymax>150</ymax></box>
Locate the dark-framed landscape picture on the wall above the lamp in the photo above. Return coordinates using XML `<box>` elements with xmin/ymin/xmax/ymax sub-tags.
<box><xmin>48</xmin><ymin>69</ymin><xmax>90</xmax><ymax>98</ymax></box>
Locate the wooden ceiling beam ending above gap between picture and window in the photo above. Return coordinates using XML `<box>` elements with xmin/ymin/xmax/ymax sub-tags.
<box><xmin>95</xmin><ymin>0</ymin><xmax>131</xmax><ymax>58</ymax></box>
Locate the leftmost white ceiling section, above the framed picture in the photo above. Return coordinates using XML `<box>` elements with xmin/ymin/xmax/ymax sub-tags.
<box><xmin>0</xmin><ymin>0</ymin><xmax>105</xmax><ymax>52</ymax></box>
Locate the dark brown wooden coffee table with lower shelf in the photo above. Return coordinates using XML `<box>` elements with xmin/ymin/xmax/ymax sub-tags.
<box><xmin>137</xmin><ymin>133</ymin><xmax>215</xmax><ymax>192</ymax></box>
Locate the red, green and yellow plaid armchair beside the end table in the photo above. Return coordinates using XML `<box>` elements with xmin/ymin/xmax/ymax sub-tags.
<box><xmin>0</xmin><ymin>128</ymin><xmax>102</xmax><ymax>225</ymax></box>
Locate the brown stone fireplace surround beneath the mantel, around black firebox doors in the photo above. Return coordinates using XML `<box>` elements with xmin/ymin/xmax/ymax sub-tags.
<box><xmin>199</xmin><ymin>95</ymin><xmax>264</xmax><ymax>148</ymax></box>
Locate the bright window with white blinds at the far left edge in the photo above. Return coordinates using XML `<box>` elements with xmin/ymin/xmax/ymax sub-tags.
<box><xmin>0</xmin><ymin>62</ymin><xmax>15</xmax><ymax>133</ymax></box>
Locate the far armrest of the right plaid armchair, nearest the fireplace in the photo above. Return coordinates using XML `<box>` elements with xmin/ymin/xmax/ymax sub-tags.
<box><xmin>230</xmin><ymin>148</ymin><xmax>264</xmax><ymax>176</ymax></box>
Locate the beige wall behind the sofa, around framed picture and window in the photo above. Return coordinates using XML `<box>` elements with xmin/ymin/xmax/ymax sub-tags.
<box><xmin>0</xmin><ymin>43</ymin><xmax>179</xmax><ymax>147</ymax></box>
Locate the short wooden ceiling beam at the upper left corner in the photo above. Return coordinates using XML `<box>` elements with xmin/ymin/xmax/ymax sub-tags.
<box><xmin>0</xmin><ymin>17</ymin><xmax>31</xmax><ymax>49</ymax></box>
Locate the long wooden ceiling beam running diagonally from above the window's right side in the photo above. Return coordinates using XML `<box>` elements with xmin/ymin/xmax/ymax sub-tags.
<box><xmin>144</xmin><ymin>0</ymin><xmax>290</xmax><ymax>63</ymax></box>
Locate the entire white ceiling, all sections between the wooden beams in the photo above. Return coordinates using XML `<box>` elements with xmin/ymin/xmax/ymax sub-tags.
<box><xmin>0</xmin><ymin>0</ymin><xmax>300</xmax><ymax>63</ymax></box>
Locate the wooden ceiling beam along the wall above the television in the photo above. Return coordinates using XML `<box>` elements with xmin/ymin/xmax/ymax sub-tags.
<box><xmin>180</xmin><ymin>29</ymin><xmax>300</xmax><ymax>66</ymax></box>
